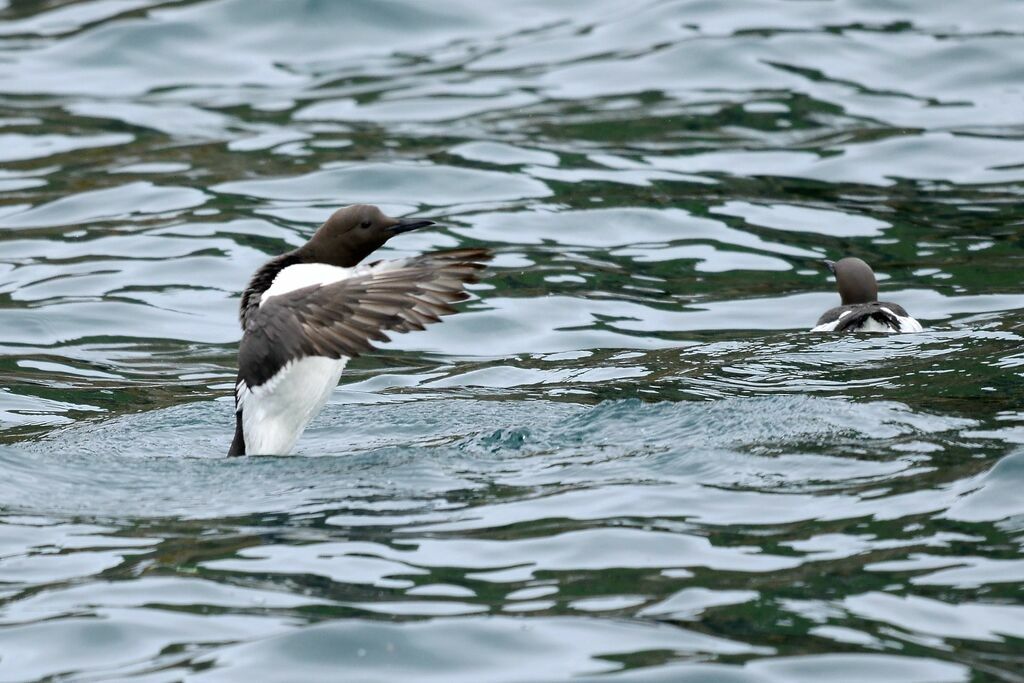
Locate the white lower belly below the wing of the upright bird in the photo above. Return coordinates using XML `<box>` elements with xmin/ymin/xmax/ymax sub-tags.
<box><xmin>236</xmin><ymin>356</ymin><xmax>348</xmax><ymax>456</ymax></box>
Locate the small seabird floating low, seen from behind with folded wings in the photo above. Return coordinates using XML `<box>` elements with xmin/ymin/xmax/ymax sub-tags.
<box><xmin>811</xmin><ymin>257</ymin><xmax>924</xmax><ymax>332</ymax></box>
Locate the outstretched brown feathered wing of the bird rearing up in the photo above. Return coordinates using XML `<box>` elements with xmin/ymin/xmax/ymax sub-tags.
<box><xmin>239</xmin><ymin>249</ymin><xmax>490</xmax><ymax>387</ymax></box>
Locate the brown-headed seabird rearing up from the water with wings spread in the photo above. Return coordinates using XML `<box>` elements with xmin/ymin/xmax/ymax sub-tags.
<box><xmin>227</xmin><ymin>205</ymin><xmax>490</xmax><ymax>456</ymax></box>
